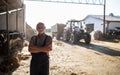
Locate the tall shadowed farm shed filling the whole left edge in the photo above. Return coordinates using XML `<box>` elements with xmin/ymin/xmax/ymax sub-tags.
<box><xmin>0</xmin><ymin>0</ymin><xmax>25</xmax><ymax>75</ymax></box>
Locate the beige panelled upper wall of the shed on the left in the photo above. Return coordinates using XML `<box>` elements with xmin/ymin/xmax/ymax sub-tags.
<box><xmin>0</xmin><ymin>7</ymin><xmax>25</xmax><ymax>32</ymax></box>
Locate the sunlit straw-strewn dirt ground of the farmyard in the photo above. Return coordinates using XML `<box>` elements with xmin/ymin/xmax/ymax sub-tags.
<box><xmin>12</xmin><ymin>40</ymin><xmax>120</xmax><ymax>75</ymax></box>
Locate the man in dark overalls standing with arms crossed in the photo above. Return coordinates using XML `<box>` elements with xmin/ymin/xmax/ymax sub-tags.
<box><xmin>29</xmin><ymin>22</ymin><xmax>52</xmax><ymax>75</ymax></box>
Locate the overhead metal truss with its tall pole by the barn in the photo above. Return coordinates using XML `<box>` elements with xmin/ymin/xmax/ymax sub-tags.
<box><xmin>26</xmin><ymin>0</ymin><xmax>106</xmax><ymax>35</ymax></box>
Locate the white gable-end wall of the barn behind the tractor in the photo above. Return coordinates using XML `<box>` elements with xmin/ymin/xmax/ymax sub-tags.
<box><xmin>84</xmin><ymin>17</ymin><xmax>103</xmax><ymax>32</ymax></box>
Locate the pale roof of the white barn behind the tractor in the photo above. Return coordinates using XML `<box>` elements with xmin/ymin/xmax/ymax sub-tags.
<box><xmin>84</xmin><ymin>15</ymin><xmax>120</xmax><ymax>21</ymax></box>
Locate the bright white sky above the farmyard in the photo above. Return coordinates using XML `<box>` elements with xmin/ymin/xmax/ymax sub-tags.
<box><xmin>24</xmin><ymin>0</ymin><xmax>120</xmax><ymax>28</ymax></box>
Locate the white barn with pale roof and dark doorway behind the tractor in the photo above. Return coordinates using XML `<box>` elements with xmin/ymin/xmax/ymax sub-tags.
<box><xmin>83</xmin><ymin>14</ymin><xmax>120</xmax><ymax>33</ymax></box>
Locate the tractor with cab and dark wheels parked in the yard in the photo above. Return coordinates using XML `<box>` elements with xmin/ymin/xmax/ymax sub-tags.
<box><xmin>63</xmin><ymin>20</ymin><xmax>91</xmax><ymax>44</ymax></box>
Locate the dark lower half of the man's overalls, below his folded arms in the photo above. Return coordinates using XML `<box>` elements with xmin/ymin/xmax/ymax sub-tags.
<box><xmin>30</xmin><ymin>54</ymin><xmax>49</xmax><ymax>75</ymax></box>
